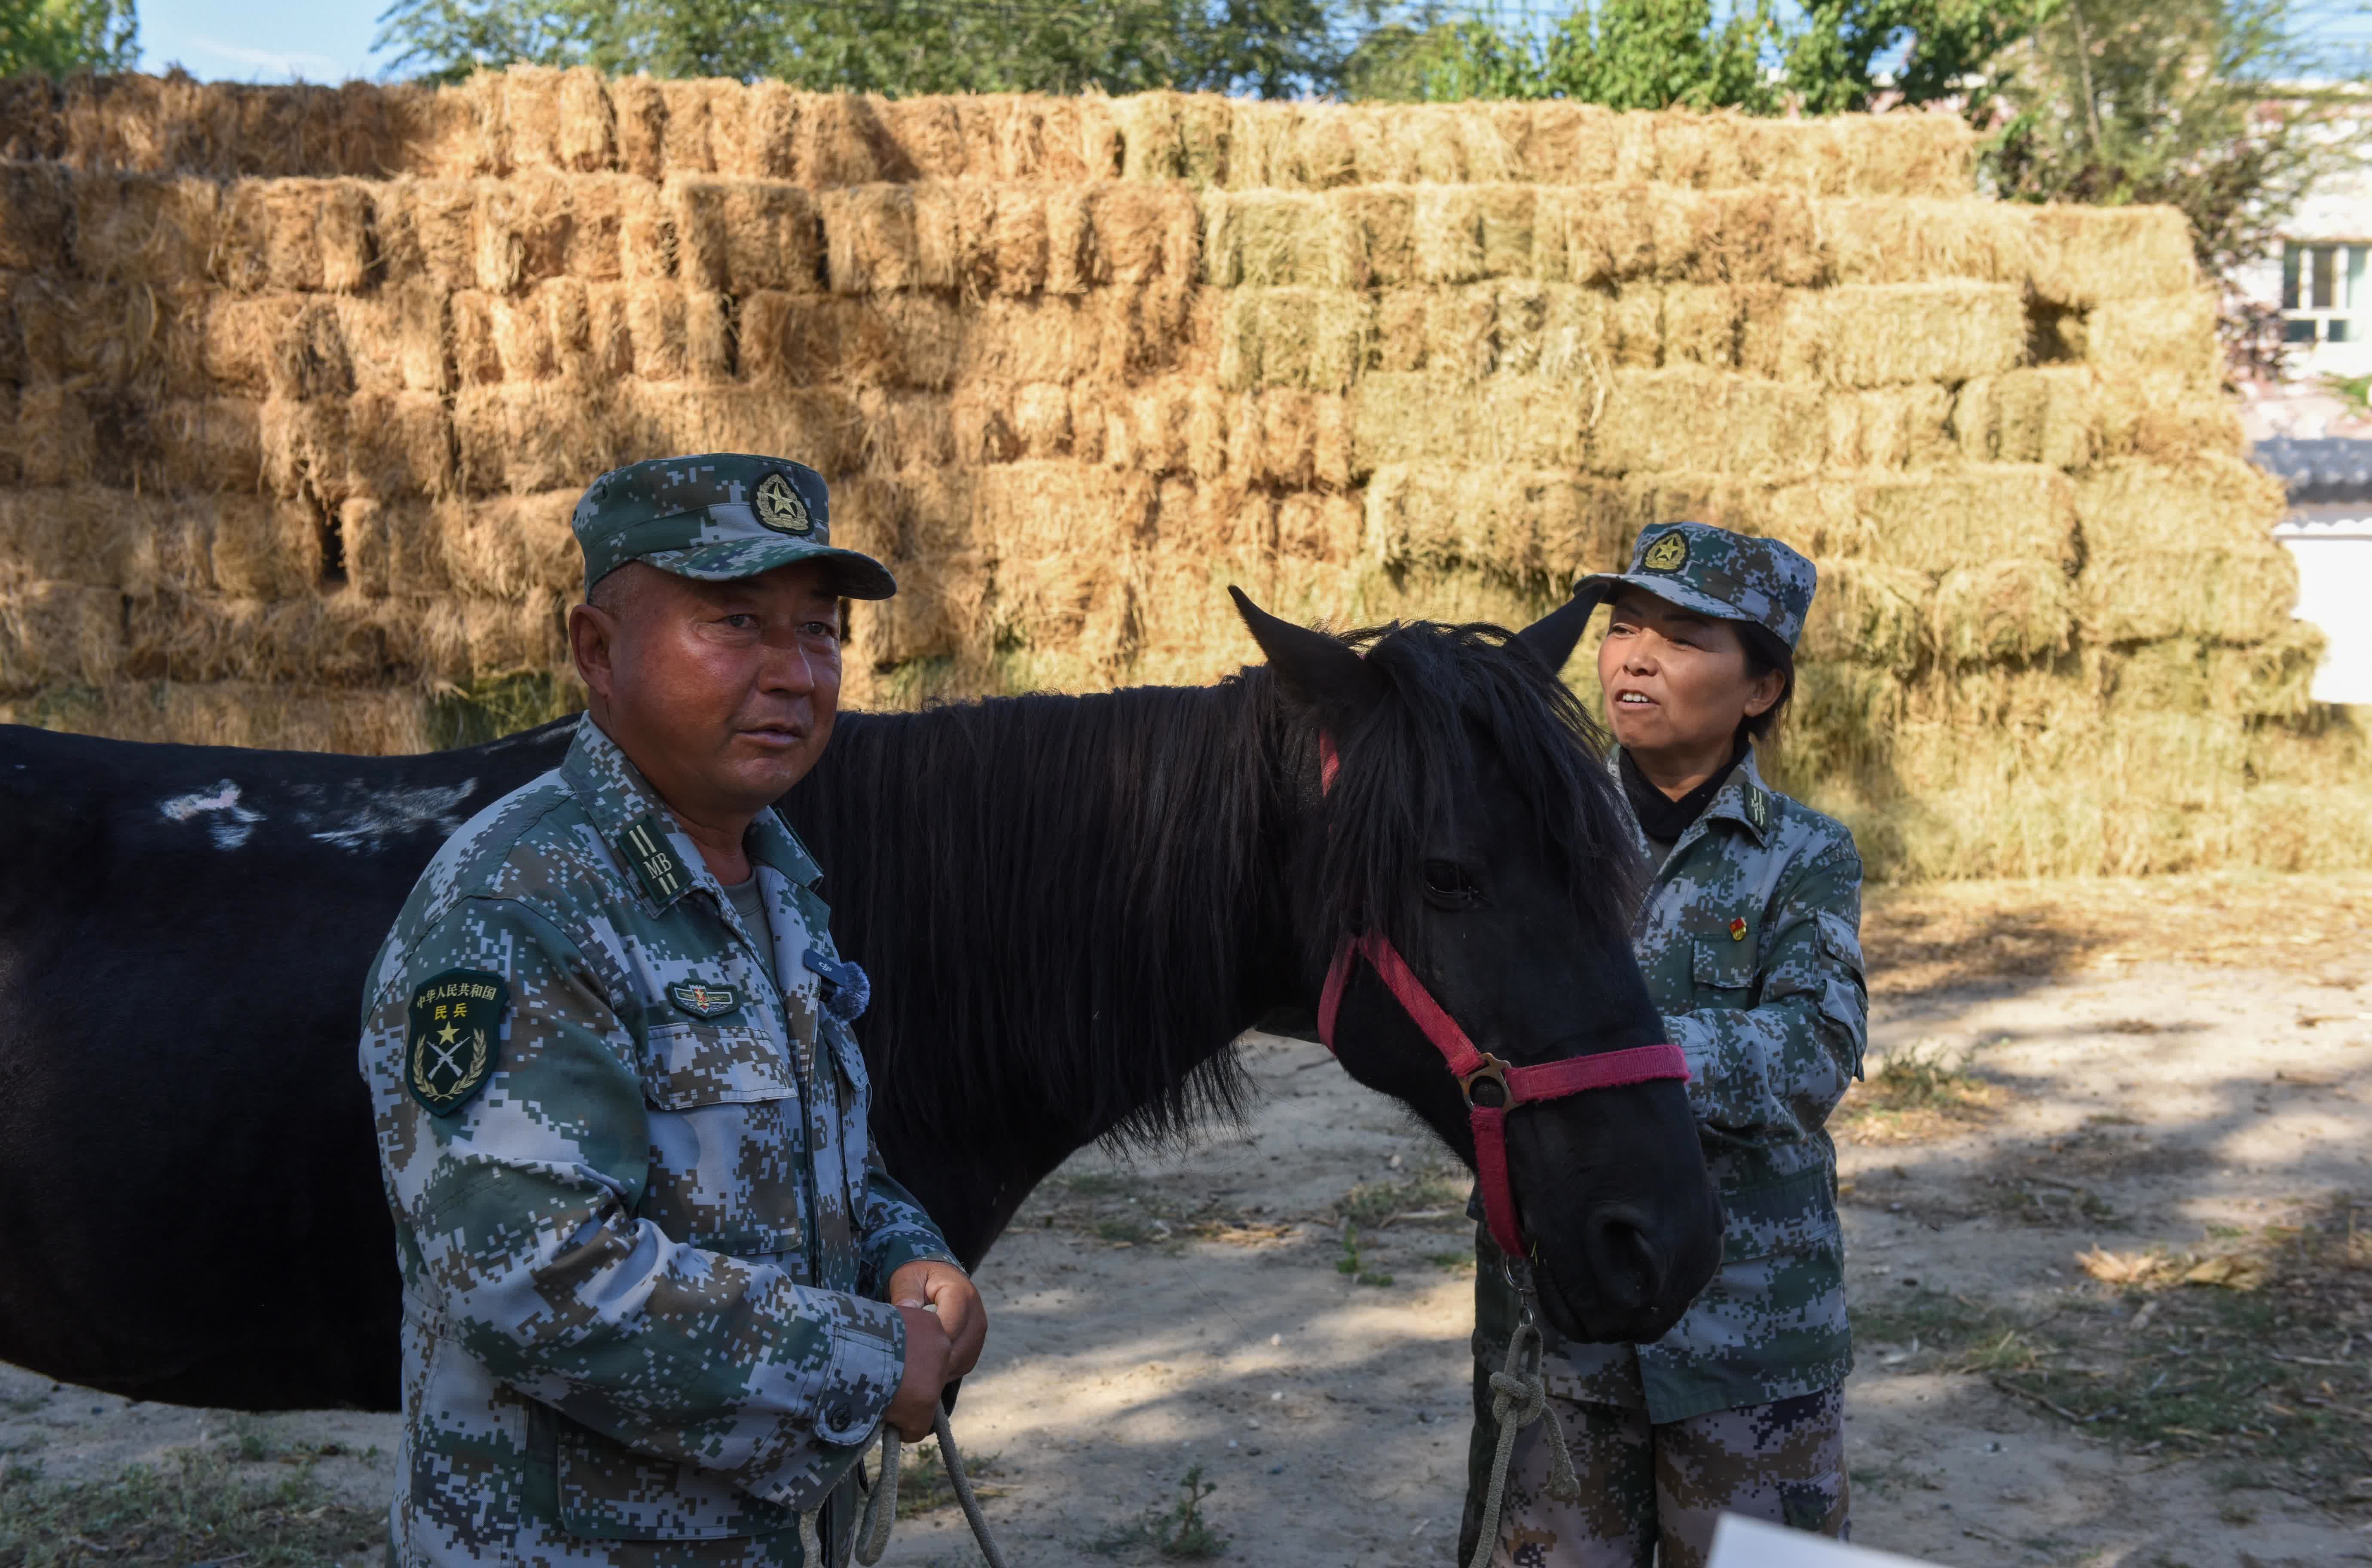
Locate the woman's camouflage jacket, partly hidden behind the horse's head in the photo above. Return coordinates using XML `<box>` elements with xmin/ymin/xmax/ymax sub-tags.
<box><xmin>1475</xmin><ymin>754</ymin><xmax>1867</xmax><ymax>1421</ymax></box>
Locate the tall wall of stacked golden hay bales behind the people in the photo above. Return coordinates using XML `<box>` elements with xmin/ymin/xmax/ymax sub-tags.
<box><xmin>0</xmin><ymin>71</ymin><xmax>2372</xmax><ymax>876</ymax></box>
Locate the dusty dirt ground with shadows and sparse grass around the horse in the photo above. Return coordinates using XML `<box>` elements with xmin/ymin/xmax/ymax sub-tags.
<box><xmin>0</xmin><ymin>878</ymin><xmax>2372</xmax><ymax>1568</ymax></box>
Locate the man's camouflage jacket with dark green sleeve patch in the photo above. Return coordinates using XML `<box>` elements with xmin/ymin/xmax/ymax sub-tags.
<box><xmin>361</xmin><ymin>719</ymin><xmax>949</xmax><ymax>1568</ymax></box>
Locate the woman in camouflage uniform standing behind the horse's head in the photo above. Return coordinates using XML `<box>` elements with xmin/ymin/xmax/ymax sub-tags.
<box><xmin>1459</xmin><ymin>522</ymin><xmax>1867</xmax><ymax>1568</ymax></box>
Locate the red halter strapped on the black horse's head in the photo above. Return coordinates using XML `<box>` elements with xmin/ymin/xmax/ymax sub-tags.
<box><xmin>1319</xmin><ymin>735</ymin><xmax>1689</xmax><ymax>1257</ymax></box>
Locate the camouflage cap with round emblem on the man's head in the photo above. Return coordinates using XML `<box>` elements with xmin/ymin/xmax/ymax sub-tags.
<box><xmin>569</xmin><ymin>453</ymin><xmax>897</xmax><ymax>598</ymax></box>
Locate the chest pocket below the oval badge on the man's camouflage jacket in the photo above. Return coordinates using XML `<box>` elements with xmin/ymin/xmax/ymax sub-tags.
<box><xmin>636</xmin><ymin>1022</ymin><xmax>807</xmax><ymax>1260</ymax></box>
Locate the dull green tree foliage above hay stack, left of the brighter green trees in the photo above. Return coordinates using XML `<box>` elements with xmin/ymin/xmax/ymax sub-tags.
<box><xmin>377</xmin><ymin>0</ymin><xmax>1340</xmax><ymax>97</ymax></box>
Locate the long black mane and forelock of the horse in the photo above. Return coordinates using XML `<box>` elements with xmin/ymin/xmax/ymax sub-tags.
<box><xmin>783</xmin><ymin>622</ymin><xmax>1637</xmax><ymax>1158</ymax></box>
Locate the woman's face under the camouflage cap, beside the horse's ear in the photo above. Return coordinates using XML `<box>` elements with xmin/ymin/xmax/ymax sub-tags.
<box><xmin>1599</xmin><ymin>588</ymin><xmax>1786</xmax><ymax>757</ymax></box>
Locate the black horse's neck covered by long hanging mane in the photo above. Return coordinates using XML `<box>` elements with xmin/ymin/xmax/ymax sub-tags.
<box><xmin>785</xmin><ymin>671</ymin><xmax>1297</xmax><ymax>1241</ymax></box>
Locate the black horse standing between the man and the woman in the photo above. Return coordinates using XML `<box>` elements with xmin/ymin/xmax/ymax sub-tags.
<box><xmin>0</xmin><ymin>603</ymin><xmax>1720</xmax><ymax>1409</ymax></box>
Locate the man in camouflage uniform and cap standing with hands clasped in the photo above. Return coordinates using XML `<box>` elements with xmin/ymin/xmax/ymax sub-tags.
<box><xmin>361</xmin><ymin>455</ymin><xmax>984</xmax><ymax>1568</ymax></box>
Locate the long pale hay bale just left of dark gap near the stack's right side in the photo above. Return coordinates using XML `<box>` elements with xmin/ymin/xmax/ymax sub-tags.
<box><xmin>1741</xmin><ymin>282</ymin><xmax>2026</xmax><ymax>387</ymax></box>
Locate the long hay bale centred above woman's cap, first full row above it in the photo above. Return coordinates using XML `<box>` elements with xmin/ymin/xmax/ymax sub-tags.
<box><xmin>1568</xmin><ymin>368</ymin><xmax>1826</xmax><ymax>479</ymax></box>
